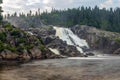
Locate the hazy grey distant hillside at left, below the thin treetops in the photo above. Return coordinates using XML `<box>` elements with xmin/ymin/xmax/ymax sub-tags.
<box><xmin>7</xmin><ymin>16</ymin><xmax>43</xmax><ymax>29</ymax></box>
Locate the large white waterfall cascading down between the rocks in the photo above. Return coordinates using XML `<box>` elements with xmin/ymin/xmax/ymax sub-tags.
<box><xmin>53</xmin><ymin>26</ymin><xmax>89</xmax><ymax>53</ymax></box>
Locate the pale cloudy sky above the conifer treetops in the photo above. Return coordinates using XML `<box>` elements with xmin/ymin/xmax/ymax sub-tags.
<box><xmin>2</xmin><ymin>0</ymin><xmax>120</xmax><ymax>14</ymax></box>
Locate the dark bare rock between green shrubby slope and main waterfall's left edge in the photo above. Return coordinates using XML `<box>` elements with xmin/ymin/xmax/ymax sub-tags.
<box><xmin>29</xmin><ymin>26</ymin><xmax>83</xmax><ymax>57</ymax></box>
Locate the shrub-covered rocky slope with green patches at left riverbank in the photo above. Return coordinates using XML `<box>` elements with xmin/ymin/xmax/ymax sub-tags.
<box><xmin>0</xmin><ymin>23</ymin><xmax>59</xmax><ymax>61</ymax></box>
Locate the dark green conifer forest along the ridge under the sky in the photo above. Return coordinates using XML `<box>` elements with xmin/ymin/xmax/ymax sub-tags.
<box><xmin>5</xmin><ymin>6</ymin><xmax>120</xmax><ymax>32</ymax></box>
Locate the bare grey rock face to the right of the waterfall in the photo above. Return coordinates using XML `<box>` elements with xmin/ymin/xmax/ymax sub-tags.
<box><xmin>71</xmin><ymin>25</ymin><xmax>120</xmax><ymax>54</ymax></box>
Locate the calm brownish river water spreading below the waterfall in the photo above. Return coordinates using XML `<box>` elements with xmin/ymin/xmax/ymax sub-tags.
<box><xmin>0</xmin><ymin>56</ymin><xmax>120</xmax><ymax>80</ymax></box>
